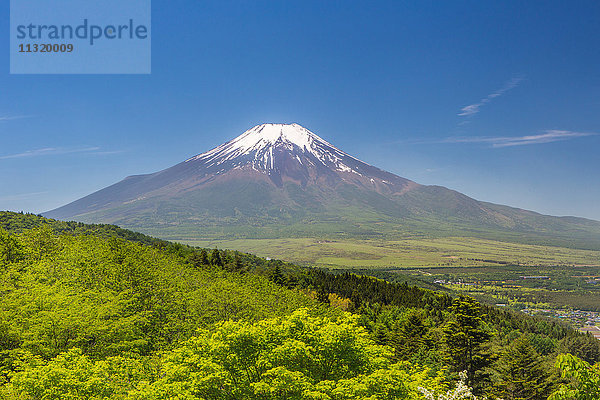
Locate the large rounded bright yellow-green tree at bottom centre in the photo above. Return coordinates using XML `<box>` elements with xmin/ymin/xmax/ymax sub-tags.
<box><xmin>133</xmin><ymin>310</ymin><xmax>444</xmax><ymax>400</ymax></box>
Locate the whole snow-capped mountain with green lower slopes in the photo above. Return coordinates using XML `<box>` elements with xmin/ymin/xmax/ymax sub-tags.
<box><xmin>44</xmin><ymin>124</ymin><xmax>600</xmax><ymax>249</ymax></box>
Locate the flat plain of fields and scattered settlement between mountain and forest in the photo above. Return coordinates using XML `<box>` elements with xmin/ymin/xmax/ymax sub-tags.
<box><xmin>180</xmin><ymin>237</ymin><xmax>600</xmax><ymax>311</ymax></box>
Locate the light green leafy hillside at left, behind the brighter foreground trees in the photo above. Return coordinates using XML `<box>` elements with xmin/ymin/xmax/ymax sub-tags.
<box><xmin>0</xmin><ymin>227</ymin><xmax>314</xmax><ymax>360</ymax></box>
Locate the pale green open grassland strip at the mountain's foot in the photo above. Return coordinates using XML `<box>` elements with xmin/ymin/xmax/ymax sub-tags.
<box><xmin>186</xmin><ymin>237</ymin><xmax>600</xmax><ymax>269</ymax></box>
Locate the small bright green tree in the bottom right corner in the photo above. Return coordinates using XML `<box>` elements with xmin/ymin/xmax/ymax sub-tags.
<box><xmin>548</xmin><ymin>354</ymin><xmax>600</xmax><ymax>400</ymax></box>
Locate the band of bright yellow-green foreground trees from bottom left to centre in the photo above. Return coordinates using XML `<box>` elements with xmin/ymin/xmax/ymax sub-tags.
<box><xmin>0</xmin><ymin>309</ymin><xmax>447</xmax><ymax>400</ymax></box>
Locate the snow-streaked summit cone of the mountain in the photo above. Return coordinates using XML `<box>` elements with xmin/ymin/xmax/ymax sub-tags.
<box><xmin>178</xmin><ymin>124</ymin><xmax>408</xmax><ymax>191</ymax></box>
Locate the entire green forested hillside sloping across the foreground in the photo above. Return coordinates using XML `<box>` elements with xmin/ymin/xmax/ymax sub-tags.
<box><xmin>0</xmin><ymin>212</ymin><xmax>600</xmax><ymax>400</ymax></box>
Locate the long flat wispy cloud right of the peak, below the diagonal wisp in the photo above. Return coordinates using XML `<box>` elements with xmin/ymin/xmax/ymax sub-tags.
<box><xmin>442</xmin><ymin>129</ymin><xmax>598</xmax><ymax>147</ymax></box>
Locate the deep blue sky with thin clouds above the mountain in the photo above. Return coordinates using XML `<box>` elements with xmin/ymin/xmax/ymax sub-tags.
<box><xmin>0</xmin><ymin>0</ymin><xmax>600</xmax><ymax>220</ymax></box>
